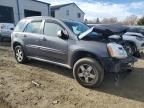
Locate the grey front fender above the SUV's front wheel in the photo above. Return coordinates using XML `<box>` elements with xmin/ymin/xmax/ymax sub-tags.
<box><xmin>68</xmin><ymin>41</ymin><xmax>110</xmax><ymax>65</ymax></box>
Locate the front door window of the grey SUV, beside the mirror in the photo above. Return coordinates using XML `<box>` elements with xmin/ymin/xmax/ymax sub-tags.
<box><xmin>44</xmin><ymin>22</ymin><xmax>63</xmax><ymax>36</ymax></box>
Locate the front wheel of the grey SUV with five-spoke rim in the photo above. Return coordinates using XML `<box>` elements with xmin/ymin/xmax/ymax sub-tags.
<box><xmin>73</xmin><ymin>58</ymin><xmax>104</xmax><ymax>88</ymax></box>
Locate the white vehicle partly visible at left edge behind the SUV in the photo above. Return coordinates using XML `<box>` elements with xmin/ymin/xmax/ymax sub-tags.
<box><xmin>0</xmin><ymin>23</ymin><xmax>14</xmax><ymax>41</ymax></box>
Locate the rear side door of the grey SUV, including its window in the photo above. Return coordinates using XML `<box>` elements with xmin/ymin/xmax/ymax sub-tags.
<box><xmin>23</xmin><ymin>21</ymin><xmax>42</xmax><ymax>57</ymax></box>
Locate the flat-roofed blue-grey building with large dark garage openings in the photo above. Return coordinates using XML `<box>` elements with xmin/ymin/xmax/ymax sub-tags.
<box><xmin>0</xmin><ymin>0</ymin><xmax>50</xmax><ymax>24</ymax></box>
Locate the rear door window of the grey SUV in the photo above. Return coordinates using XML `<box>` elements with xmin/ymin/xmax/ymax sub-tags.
<box><xmin>25</xmin><ymin>22</ymin><xmax>41</xmax><ymax>33</ymax></box>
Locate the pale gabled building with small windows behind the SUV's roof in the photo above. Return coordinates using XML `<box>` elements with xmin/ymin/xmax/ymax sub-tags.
<box><xmin>51</xmin><ymin>3</ymin><xmax>85</xmax><ymax>21</ymax></box>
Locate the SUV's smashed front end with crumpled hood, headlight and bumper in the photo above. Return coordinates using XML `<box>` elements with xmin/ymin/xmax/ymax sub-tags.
<box><xmin>79</xmin><ymin>27</ymin><xmax>137</xmax><ymax>73</ymax></box>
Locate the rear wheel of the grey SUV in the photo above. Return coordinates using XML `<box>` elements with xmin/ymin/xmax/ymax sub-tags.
<box><xmin>14</xmin><ymin>45</ymin><xmax>27</xmax><ymax>64</ymax></box>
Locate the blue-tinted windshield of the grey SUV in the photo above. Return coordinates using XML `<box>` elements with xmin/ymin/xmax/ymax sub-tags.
<box><xmin>64</xmin><ymin>21</ymin><xmax>90</xmax><ymax>36</ymax></box>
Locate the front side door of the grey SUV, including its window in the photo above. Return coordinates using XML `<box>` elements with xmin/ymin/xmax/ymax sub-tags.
<box><xmin>40</xmin><ymin>21</ymin><xmax>68</xmax><ymax>64</ymax></box>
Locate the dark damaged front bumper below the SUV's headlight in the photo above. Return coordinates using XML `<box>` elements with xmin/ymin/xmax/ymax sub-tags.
<box><xmin>103</xmin><ymin>56</ymin><xmax>137</xmax><ymax>73</ymax></box>
